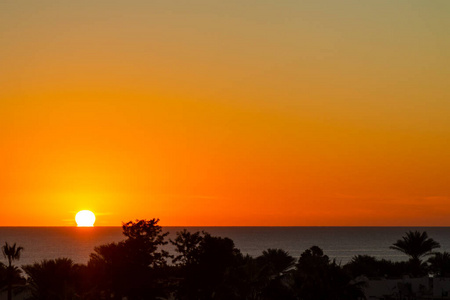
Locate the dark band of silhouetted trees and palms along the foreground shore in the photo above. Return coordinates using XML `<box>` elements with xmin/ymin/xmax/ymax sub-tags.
<box><xmin>0</xmin><ymin>219</ymin><xmax>450</xmax><ymax>300</ymax></box>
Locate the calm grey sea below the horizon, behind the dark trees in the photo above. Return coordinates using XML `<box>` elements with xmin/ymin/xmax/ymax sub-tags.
<box><xmin>0</xmin><ymin>227</ymin><xmax>450</xmax><ymax>265</ymax></box>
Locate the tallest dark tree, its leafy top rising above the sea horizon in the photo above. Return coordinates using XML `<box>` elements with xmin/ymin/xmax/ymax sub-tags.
<box><xmin>88</xmin><ymin>219</ymin><xmax>169</xmax><ymax>299</ymax></box>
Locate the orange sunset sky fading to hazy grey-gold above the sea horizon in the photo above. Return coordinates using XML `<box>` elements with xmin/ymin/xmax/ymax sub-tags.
<box><xmin>0</xmin><ymin>0</ymin><xmax>450</xmax><ymax>226</ymax></box>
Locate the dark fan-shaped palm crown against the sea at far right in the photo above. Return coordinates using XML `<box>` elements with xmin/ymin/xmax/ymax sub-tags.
<box><xmin>389</xmin><ymin>231</ymin><xmax>441</xmax><ymax>262</ymax></box>
